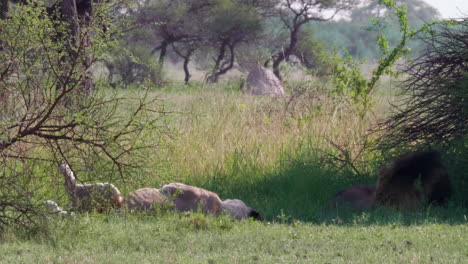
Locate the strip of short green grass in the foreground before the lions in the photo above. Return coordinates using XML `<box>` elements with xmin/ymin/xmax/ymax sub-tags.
<box><xmin>0</xmin><ymin>214</ymin><xmax>468</xmax><ymax>263</ymax></box>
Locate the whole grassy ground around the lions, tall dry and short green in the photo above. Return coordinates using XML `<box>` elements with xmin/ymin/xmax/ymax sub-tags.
<box><xmin>0</xmin><ymin>81</ymin><xmax>468</xmax><ymax>263</ymax></box>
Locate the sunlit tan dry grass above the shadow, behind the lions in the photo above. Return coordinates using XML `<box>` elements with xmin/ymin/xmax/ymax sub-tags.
<box><xmin>156</xmin><ymin>81</ymin><xmax>393</xmax><ymax>182</ymax></box>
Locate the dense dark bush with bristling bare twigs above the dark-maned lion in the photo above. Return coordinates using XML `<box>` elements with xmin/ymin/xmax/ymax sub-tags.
<box><xmin>382</xmin><ymin>19</ymin><xmax>468</xmax><ymax>148</ymax></box>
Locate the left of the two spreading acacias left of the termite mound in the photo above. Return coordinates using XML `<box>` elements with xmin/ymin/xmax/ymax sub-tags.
<box><xmin>125</xmin><ymin>0</ymin><xmax>215</xmax><ymax>83</ymax></box>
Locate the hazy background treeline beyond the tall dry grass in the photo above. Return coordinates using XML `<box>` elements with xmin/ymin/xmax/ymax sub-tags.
<box><xmin>107</xmin><ymin>0</ymin><xmax>438</xmax><ymax>85</ymax></box>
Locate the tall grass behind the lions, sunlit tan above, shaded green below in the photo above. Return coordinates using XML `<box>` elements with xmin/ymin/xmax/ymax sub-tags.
<box><xmin>136</xmin><ymin>83</ymin><xmax>394</xmax><ymax>221</ymax></box>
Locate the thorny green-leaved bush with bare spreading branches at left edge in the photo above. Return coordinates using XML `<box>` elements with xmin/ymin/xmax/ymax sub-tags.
<box><xmin>0</xmin><ymin>2</ymin><xmax>167</xmax><ymax>229</ymax></box>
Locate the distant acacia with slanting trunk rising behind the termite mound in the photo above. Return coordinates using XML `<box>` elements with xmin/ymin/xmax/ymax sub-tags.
<box><xmin>265</xmin><ymin>0</ymin><xmax>358</xmax><ymax>79</ymax></box>
